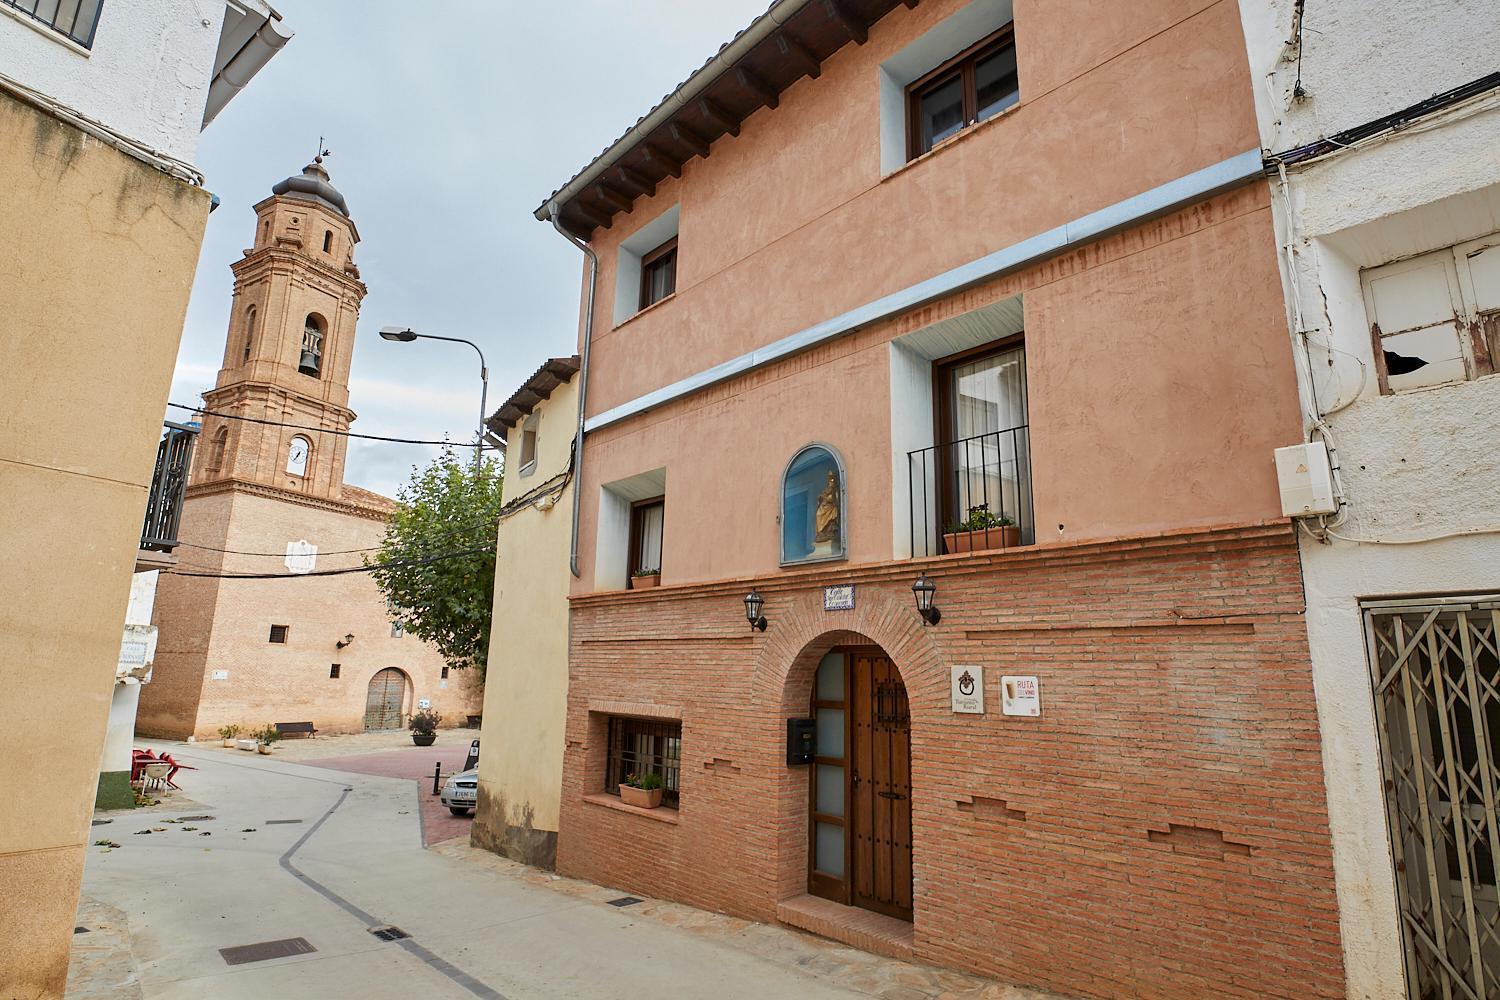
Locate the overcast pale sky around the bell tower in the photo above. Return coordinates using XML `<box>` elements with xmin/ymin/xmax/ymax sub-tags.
<box><xmin>170</xmin><ymin>0</ymin><xmax>768</xmax><ymax>495</ymax></box>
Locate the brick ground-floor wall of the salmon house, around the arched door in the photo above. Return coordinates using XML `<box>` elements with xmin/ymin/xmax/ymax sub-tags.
<box><xmin>558</xmin><ymin>525</ymin><xmax>1344</xmax><ymax>1000</ymax></box>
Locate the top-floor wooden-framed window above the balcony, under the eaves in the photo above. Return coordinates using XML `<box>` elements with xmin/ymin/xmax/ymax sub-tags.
<box><xmin>906</xmin><ymin>24</ymin><xmax>1022</xmax><ymax>159</ymax></box>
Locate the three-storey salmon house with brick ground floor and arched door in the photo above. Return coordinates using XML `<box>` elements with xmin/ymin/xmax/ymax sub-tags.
<box><xmin>537</xmin><ymin>0</ymin><xmax>1346</xmax><ymax>1000</ymax></box>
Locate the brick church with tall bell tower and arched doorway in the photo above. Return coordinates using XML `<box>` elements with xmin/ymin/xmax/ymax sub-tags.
<box><xmin>137</xmin><ymin>160</ymin><xmax>482</xmax><ymax>739</ymax></box>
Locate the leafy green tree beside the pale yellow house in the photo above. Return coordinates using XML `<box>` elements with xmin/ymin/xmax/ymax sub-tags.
<box><xmin>366</xmin><ymin>450</ymin><xmax>501</xmax><ymax>678</ymax></box>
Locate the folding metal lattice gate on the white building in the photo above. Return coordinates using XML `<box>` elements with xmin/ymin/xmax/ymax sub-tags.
<box><xmin>1365</xmin><ymin>598</ymin><xmax>1500</xmax><ymax>1000</ymax></box>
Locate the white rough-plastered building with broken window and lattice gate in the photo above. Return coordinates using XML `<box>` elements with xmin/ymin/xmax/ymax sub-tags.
<box><xmin>1241</xmin><ymin>0</ymin><xmax>1500</xmax><ymax>1000</ymax></box>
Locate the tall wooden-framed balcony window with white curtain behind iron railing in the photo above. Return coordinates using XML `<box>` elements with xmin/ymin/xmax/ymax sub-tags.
<box><xmin>933</xmin><ymin>334</ymin><xmax>1034</xmax><ymax>544</ymax></box>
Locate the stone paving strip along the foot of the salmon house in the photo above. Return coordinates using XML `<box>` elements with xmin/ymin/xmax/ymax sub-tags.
<box><xmin>431</xmin><ymin>838</ymin><xmax>1067</xmax><ymax>1000</ymax></box>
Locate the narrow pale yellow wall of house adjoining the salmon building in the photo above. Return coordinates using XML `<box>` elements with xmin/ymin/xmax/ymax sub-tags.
<box><xmin>474</xmin><ymin>375</ymin><xmax>581</xmax><ymax>867</ymax></box>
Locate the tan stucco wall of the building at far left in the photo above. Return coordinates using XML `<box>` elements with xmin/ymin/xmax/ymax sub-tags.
<box><xmin>0</xmin><ymin>89</ymin><xmax>209</xmax><ymax>997</ymax></box>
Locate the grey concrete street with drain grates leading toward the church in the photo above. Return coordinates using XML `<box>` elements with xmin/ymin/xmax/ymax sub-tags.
<box><xmin>69</xmin><ymin>741</ymin><xmax>1050</xmax><ymax>1000</ymax></box>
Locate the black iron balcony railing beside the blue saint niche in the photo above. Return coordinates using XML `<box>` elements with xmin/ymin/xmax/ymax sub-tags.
<box><xmin>906</xmin><ymin>424</ymin><xmax>1035</xmax><ymax>558</ymax></box>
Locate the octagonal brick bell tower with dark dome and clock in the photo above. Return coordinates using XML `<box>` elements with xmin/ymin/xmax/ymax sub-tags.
<box><xmin>192</xmin><ymin>151</ymin><xmax>366</xmax><ymax>499</ymax></box>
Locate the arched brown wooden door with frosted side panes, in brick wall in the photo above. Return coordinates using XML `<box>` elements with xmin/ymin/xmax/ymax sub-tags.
<box><xmin>807</xmin><ymin>646</ymin><xmax>912</xmax><ymax>921</ymax></box>
